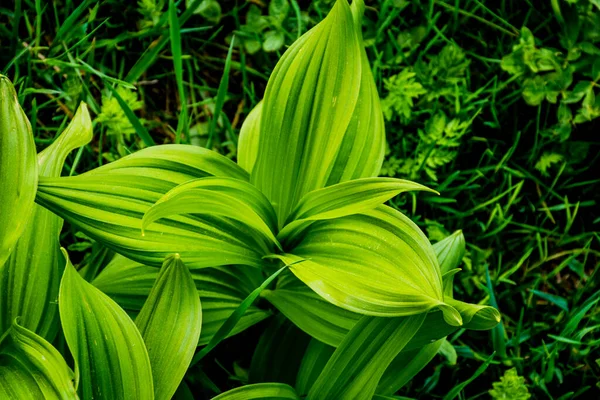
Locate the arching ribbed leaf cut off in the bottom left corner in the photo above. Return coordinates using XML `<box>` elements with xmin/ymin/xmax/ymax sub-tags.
<box><xmin>0</xmin><ymin>322</ymin><xmax>78</xmax><ymax>400</ymax></box>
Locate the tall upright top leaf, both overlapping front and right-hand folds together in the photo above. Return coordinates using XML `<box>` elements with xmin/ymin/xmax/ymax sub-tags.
<box><xmin>246</xmin><ymin>0</ymin><xmax>384</xmax><ymax>227</ymax></box>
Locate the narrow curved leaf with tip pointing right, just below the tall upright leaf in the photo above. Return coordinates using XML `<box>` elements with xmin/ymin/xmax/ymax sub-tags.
<box><xmin>278</xmin><ymin>178</ymin><xmax>436</xmax><ymax>241</ymax></box>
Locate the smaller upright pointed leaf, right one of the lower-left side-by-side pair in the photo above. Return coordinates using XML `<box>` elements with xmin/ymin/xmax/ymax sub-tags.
<box><xmin>135</xmin><ymin>254</ymin><xmax>202</xmax><ymax>400</ymax></box>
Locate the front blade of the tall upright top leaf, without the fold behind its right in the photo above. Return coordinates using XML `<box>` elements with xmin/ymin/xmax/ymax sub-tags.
<box><xmin>251</xmin><ymin>0</ymin><xmax>364</xmax><ymax>226</ymax></box>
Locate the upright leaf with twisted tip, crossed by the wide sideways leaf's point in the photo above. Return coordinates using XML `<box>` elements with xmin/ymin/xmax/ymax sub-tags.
<box><xmin>0</xmin><ymin>104</ymin><xmax>92</xmax><ymax>340</ymax></box>
